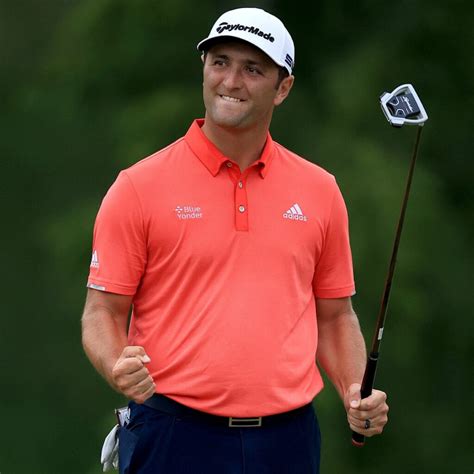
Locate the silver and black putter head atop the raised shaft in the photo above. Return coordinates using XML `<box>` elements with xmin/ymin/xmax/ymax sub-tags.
<box><xmin>380</xmin><ymin>84</ymin><xmax>428</xmax><ymax>127</ymax></box>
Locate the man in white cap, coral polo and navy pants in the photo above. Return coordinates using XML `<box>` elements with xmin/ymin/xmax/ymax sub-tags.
<box><xmin>82</xmin><ymin>8</ymin><xmax>388</xmax><ymax>474</ymax></box>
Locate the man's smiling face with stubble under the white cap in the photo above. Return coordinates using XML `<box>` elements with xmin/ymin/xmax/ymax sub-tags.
<box><xmin>203</xmin><ymin>42</ymin><xmax>293</xmax><ymax>129</ymax></box>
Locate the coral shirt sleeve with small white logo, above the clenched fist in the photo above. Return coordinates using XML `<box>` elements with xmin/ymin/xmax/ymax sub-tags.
<box><xmin>87</xmin><ymin>171</ymin><xmax>147</xmax><ymax>295</ymax></box>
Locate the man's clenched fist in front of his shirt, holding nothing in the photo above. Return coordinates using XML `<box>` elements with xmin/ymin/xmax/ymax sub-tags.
<box><xmin>112</xmin><ymin>346</ymin><xmax>156</xmax><ymax>404</ymax></box>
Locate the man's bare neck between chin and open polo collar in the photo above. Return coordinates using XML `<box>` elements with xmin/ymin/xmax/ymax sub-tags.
<box><xmin>202</xmin><ymin>119</ymin><xmax>268</xmax><ymax>171</ymax></box>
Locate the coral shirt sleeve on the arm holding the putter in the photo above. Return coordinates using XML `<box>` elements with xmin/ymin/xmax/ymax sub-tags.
<box><xmin>313</xmin><ymin>180</ymin><xmax>355</xmax><ymax>298</ymax></box>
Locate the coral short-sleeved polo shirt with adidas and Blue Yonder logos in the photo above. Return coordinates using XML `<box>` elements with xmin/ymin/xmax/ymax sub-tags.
<box><xmin>88</xmin><ymin>120</ymin><xmax>354</xmax><ymax>417</ymax></box>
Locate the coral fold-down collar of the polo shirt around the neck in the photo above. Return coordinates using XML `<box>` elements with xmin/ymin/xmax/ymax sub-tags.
<box><xmin>184</xmin><ymin>119</ymin><xmax>274</xmax><ymax>178</ymax></box>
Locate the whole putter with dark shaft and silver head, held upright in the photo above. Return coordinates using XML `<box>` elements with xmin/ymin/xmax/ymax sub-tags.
<box><xmin>352</xmin><ymin>84</ymin><xmax>428</xmax><ymax>447</ymax></box>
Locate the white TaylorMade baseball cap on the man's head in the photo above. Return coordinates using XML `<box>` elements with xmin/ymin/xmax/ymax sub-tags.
<box><xmin>197</xmin><ymin>8</ymin><xmax>295</xmax><ymax>74</ymax></box>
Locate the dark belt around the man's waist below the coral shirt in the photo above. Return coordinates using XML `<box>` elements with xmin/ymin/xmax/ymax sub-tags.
<box><xmin>144</xmin><ymin>393</ymin><xmax>311</xmax><ymax>428</ymax></box>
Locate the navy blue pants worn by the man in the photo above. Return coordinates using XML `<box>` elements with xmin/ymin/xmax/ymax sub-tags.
<box><xmin>119</xmin><ymin>402</ymin><xmax>320</xmax><ymax>474</ymax></box>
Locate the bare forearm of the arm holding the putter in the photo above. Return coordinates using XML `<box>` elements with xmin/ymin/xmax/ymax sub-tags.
<box><xmin>317</xmin><ymin>311</ymin><xmax>367</xmax><ymax>399</ymax></box>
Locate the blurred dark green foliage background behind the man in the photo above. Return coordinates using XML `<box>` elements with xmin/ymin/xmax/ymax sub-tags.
<box><xmin>0</xmin><ymin>0</ymin><xmax>474</xmax><ymax>474</ymax></box>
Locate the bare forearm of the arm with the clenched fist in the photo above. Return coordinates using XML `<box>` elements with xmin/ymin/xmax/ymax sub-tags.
<box><xmin>82</xmin><ymin>305</ymin><xmax>127</xmax><ymax>388</ymax></box>
